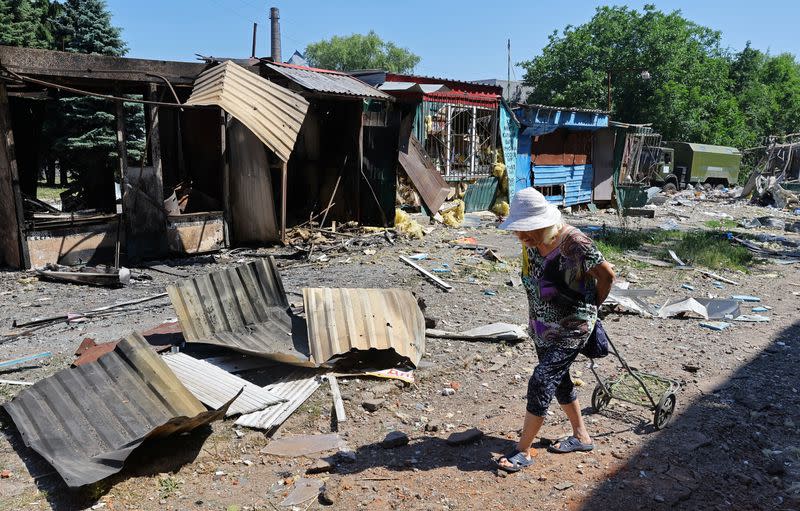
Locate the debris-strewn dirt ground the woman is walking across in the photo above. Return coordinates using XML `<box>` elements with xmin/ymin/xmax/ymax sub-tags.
<box><xmin>0</xmin><ymin>202</ymin><xmax>800</xmax><ymax>511</ymax></box>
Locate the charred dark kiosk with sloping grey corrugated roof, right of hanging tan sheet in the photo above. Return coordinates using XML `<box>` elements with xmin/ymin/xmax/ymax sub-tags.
<box><xmin>261</xmin><ymin>59</ymin><xmax>400</xmax><ymax>226</ymax></box>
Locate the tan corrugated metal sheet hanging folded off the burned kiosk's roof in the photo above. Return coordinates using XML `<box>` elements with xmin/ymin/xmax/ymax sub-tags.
<box><xmin>186</xmin><ymin>61</ymin><xmax>308</xmax><ymax>161</ymax></box>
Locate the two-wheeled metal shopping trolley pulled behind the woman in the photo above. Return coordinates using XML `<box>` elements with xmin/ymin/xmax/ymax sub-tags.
<box><xmin>590</xmin><ymin>340</ymin><xmax>680</xmax><ymax>429</ymax></box>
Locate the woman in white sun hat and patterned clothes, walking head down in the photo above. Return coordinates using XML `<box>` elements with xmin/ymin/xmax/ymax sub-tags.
<box><xmin>497</xmin><ymin>188</ymin><xmax>614</xmax><ymax>472</ymax></box>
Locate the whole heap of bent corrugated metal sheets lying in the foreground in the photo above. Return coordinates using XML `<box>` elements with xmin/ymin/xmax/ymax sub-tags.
<box><xmin>4</xmin><ymin>258</ymin><xmax>432</xmax><ymax>487</ymax></box>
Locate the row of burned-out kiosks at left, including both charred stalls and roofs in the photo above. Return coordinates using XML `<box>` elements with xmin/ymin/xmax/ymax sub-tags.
<box><xmin>0</xmin><ymin>47</ymin><xmax>400</xmax><ymax>268</ymax></box>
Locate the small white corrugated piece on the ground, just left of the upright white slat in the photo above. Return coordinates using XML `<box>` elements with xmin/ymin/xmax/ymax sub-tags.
<box><xmin>236</xmin><ymin>370</ymin><xmax>321</xmax><ymax>430</ymax></box>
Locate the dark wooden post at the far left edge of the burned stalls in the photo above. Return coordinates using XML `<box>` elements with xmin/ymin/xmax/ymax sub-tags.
<box><xmin>0</xmin><ymin>80</ymin><xmax>31</xmax><ymax>269</ymax></box>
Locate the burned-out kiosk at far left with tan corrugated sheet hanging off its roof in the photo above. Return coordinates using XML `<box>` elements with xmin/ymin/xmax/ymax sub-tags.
<box><xmin>0</xmin><ymin>47</ymin><xmax>308</xmax><ymax>268</ymax></box>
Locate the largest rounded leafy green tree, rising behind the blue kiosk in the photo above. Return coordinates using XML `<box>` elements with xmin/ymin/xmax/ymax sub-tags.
<box><xmin>522</xmin><ymin>5</ymin><xmax>751</xmax><ymax>146</ymax></box>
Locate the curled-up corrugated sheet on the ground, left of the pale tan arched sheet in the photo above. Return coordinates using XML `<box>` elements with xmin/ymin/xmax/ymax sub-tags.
<box><xmin>167</xmin><ymin>258</ymin><xmax>312</xmax><ymax>365</ymax></box>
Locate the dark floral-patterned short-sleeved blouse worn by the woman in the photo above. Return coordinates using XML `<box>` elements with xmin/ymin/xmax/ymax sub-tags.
<box><xmin>522</xmin><ymin>227</ymin><xmax>605</xmax><ymax>348</ymax></box>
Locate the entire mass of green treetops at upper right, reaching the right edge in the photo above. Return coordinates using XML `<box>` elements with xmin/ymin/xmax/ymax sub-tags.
<box><xmin>521</xmin><ymin>5</ymin><xmax>800</xmax><ymax>148</ymax></box>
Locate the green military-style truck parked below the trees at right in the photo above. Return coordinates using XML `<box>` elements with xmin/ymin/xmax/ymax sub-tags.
<box><xmin>651</xmin><ymin>142</ymin><xmax>742</xmax><ymax>191</ymax></box>
